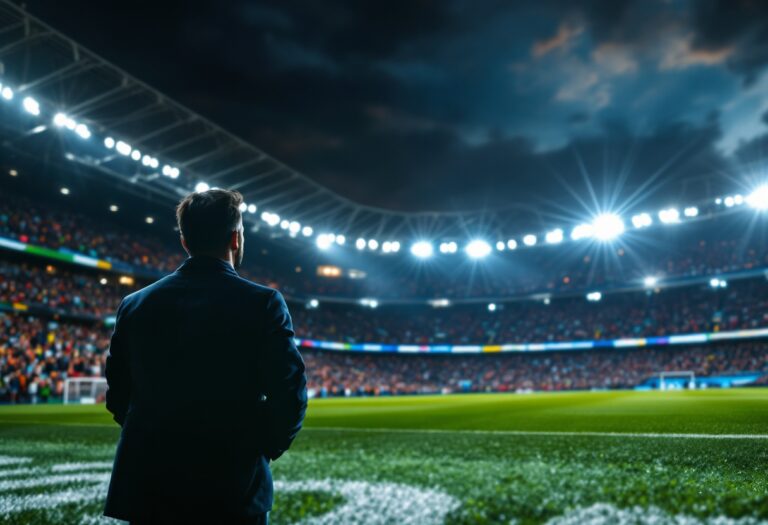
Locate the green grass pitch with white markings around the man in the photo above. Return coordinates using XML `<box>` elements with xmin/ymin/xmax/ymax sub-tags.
<box><xmin>0</xmin><ymin>389</ymin><xmax>768</xmax><ymax>525</ymax></box>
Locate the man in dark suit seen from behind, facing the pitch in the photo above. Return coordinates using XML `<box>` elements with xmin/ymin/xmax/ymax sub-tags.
<box><xmin>104</xmin><ymin>190</ymin><xmax>307</xmax><ymax>524</ymax></box>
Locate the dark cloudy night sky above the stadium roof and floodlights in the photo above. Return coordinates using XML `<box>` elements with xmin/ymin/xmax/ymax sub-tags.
<box><xmin>27</xmin><ymin>0</ymin><xmax>768</xmax><ymax>210</ymax></box>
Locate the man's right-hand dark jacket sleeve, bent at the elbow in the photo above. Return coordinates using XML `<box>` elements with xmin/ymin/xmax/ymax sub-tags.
<box><xmin>262</xmin><ymin>291</ymin><xmax>307</xmax><ymax>459</ymax></box>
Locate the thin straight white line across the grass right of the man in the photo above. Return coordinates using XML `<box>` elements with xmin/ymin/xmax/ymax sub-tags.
<box><xmin>306</xmin><ymin>427</ymin><xmax>768</xmax><ymax>439</ymax></box>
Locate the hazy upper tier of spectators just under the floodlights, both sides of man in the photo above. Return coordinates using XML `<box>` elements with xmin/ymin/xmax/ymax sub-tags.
<box><xmin>0</xmin><ymin>189</ymin><xmax>768</xmax><ymax>298</ymax></box>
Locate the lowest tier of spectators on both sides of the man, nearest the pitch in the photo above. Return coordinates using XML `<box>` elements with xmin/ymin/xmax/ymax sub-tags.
<box><xmin>0</xmin><ymin>313</ymin><xmax>768</xmax><ymax>403</ymax></box>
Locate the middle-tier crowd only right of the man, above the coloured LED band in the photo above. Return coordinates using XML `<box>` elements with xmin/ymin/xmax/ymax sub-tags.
<box><xmin>293</xmin><ymin>277</ymin><xmax>768</xmax><ymax>344</ymax></box>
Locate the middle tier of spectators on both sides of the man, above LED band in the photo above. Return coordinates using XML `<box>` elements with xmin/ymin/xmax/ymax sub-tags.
<box><xmin>0</xmin><ymin>260</ymin><xmax>768</xmax><ymax>344</ymax></box>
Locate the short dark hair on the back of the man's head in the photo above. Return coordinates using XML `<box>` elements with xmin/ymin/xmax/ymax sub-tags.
<box><xmin>176</xmin><ymin>189</ymin><xmax>243</xmax><ymax>254</ymax></box>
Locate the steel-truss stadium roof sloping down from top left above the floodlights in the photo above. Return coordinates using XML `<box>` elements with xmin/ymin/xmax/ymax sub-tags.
<box><xmin>0</xmin><ymin>0</ymin><xmax>520</xmax><ymax>238</ymax></box>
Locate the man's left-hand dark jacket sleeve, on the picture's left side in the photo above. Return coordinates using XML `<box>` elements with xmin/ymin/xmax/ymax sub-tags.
<box><xmin>105</xmin><ymin>302</ymin><xmax>131</xmax><ymax>426</ymax></box>
